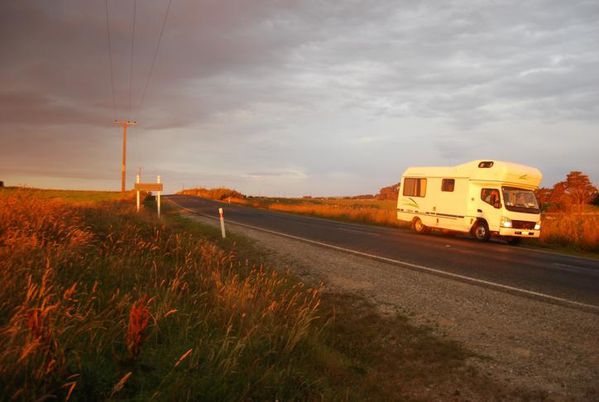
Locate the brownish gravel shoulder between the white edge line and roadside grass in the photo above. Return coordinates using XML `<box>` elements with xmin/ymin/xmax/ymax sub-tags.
<box><xmin>189</xmin><ymin>215</ymin><xmax>599</xmax><ymax>401</ymax></box>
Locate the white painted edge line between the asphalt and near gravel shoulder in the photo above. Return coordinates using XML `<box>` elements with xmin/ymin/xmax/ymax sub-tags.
<box><xmin>173</xmin><ymin>201</ymin><xmax>599</xmax><ymax>313</ymax></box>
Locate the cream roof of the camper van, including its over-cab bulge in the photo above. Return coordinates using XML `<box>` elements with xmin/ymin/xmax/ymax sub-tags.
<box><xmin>404</xmin><ymin>159</ymin><xmax>543</xmax><ymax>188</ymax></box>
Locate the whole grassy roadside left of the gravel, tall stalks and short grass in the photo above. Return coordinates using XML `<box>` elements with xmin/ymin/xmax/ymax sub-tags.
<box><xmin>0</xmin><ymin>190</ymin><xmax>544</xmax><ymax>401</ymax></box>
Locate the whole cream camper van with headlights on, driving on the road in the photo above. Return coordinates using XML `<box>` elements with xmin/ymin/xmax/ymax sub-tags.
<box><xmin>397</xmin><ymin>160</ymin><xmax>542</xmax><ymax>244</ymax></box>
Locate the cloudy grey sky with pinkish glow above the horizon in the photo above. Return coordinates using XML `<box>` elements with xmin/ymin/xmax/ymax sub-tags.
<box><xmin>0</xmin><ymin>0</ymin><xmax>599</xmax><ymax>196</ymax></box>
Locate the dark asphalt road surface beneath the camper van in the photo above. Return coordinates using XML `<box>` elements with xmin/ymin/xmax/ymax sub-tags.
<box><xmin>168</xmin><ymin>195</ymin><xmax>599</xmax><ymax>311</ymax></box>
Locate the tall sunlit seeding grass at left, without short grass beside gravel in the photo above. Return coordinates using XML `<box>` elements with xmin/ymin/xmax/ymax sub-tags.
<box><xmin>0</xmin><ymin>190</ymin><xmax>320</xmax><ymax>401</ymax></box>
